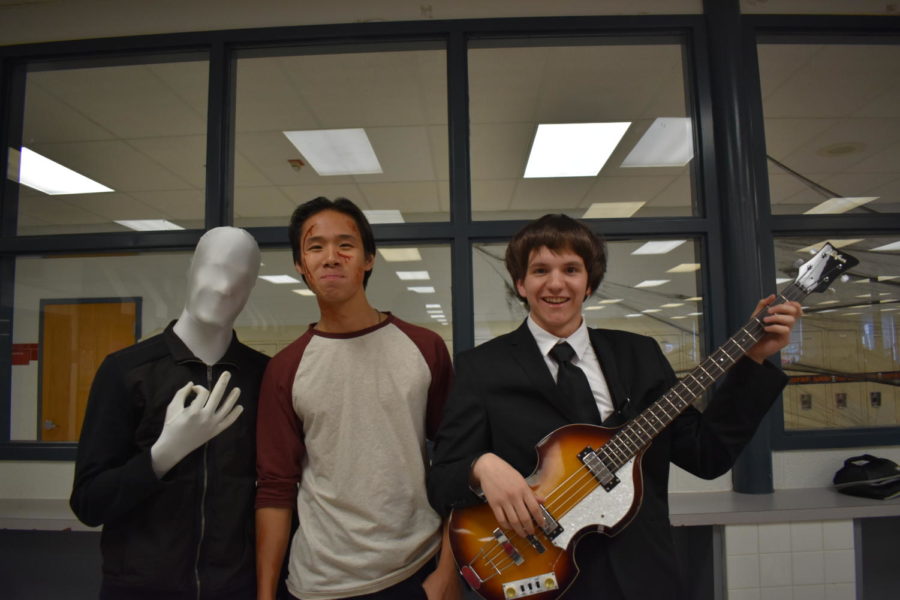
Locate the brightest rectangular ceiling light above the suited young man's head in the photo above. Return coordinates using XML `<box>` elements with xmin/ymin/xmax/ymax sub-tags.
<box><xmin>525</xmin><ymin>122</ymin><xmax>631</xmax><ymax>179</ymax></box>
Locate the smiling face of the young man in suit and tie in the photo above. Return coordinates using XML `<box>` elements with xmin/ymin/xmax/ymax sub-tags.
<box><xmin>516</xmin><ymin>246</ymin><xmax>591</xmax><ymax>337</ymax></box>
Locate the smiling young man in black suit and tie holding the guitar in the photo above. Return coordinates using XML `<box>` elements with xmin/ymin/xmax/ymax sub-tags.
<box><xmin>428</xmin><ymin>215</ymin><xmax>801</xmax><ymax>600</ymax></box>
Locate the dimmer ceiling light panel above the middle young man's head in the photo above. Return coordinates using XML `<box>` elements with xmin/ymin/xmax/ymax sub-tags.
<box><xmin>284</xmin><ymin>129</ymin><xmax>382</xmax><ymax>176</ymax></box>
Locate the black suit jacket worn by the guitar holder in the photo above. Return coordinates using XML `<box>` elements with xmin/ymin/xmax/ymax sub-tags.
<box><xmin>428</xmin><ymin>323</ymin><xmax>787</xmax><ymax>598</ymax></box>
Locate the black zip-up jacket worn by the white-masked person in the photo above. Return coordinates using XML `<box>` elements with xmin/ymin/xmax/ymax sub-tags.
<box><xmin>70</xmin><ymin>323</ymin><xmax>268</xmax><ymax>599</ymax></box>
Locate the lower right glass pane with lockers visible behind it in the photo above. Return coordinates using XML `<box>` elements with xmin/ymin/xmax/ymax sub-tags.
<box><xmin>775</xmin><ymin>237</ymin><xmax>900</xmax><ymax>430</ymax></box>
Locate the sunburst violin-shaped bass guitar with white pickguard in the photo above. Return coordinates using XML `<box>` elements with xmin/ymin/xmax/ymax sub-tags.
<box><xmin>449</xmin><ymin>243</ymin><xmax>859</xmax><ymax>600</ymax></box>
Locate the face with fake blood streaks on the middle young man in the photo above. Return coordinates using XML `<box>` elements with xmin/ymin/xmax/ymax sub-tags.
<box><xmin>295</xmin><ymin>210</ymin><xmax>375</xmax><ymax>304</ymax></box>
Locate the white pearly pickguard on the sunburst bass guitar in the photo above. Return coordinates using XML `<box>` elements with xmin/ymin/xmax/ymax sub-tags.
<box><xmin>553</xmin><ymin>458</ymin><xmax>634</xmax><ymax>549</ymax></box>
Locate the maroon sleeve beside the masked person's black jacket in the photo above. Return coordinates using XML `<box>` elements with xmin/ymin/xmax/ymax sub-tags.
<box><xmin>256</xmin><ymin>333</ymin><xmax>311</xmax><ymax>508</ymax></box>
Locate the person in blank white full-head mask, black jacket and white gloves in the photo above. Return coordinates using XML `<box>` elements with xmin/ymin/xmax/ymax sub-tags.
<box><xmin>70</xmin><ymin>227</ymin><xmax>268</xmax><ymax>600</ymax></box>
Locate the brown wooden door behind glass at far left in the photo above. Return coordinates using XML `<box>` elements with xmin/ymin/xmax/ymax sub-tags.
<box><xmin>38</xmin><ymin>298</ymin><xmax>140</xmax><ymax>442</ymax></box>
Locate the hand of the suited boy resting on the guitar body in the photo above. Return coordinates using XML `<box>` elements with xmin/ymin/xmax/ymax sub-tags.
<box><xmin>471</xmin><ymin>452</ymin><xmax>544</xmax><ymax>537</ymax></box>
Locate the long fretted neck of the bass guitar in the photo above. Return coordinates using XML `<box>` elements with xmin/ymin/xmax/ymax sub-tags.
<box><xmin>597</xmin><ymin>284</ymin><xmax>809</xmax><ymax>471</ymax></box>
